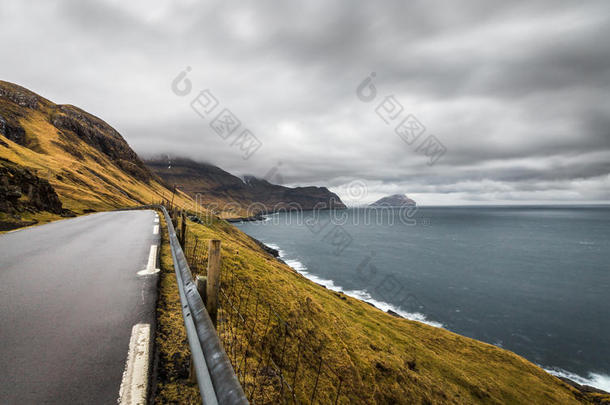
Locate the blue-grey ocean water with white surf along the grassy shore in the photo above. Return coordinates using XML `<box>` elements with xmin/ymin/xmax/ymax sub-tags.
<box><xmin>237</xmin><ymin>206</ymin><xmax>610</xmax><ymax>391</ymax></box>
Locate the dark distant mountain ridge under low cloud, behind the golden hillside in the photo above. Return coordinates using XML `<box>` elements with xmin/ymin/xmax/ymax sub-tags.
<box><xmin>145</xmin><ymin>158</ymin><xmax>345</xmax><ymax>216</ymax></box>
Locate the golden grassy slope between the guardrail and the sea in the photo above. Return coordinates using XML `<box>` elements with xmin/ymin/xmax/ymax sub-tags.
<box><xmin>169</xmin><ymin>213</ymin><xmax>610</xmax><ymax>404</ymax></box>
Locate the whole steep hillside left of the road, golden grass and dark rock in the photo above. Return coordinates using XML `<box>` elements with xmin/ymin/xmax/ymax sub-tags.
<box><xmin>0</xmin><ymin>81</ymin><xmax>192</xmax><ymax>230</ymax></box>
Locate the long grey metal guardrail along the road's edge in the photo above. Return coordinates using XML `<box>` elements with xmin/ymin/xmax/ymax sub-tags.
<box><xmin>158</xmin><ymin>205</ymin><xmax>248</xmax><ymax>405</ymax></box>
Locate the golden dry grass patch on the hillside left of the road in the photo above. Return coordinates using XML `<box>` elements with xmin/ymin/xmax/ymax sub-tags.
<box><xmin>0</xmin><ymin>89</ymin><xmax>195</xmax><ymax>220</ymax></box>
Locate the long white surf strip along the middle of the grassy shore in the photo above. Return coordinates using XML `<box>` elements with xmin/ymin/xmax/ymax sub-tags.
<box><xmin>265</xmin><ymin>242</ymin><xmax>443</xmax><ymax>328</ymax></box>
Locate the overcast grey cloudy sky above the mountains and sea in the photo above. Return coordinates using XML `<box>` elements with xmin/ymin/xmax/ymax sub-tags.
<box><xmin>0</xmin><ymin>0</ymin><xmax>610</xmax><ymax>204</ymax></box>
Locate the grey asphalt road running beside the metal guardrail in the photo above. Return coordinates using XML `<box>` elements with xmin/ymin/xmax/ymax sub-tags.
<box><xmin>0</xmin><ymin>210</ymin><xmax>159</xmax><ymax>404</ymax></box>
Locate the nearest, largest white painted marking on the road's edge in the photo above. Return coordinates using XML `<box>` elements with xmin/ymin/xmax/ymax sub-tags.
<box><xmin>118</xmin><ymin>323</ymin><xmax>150</xmax><ymax>405</ymax></box>
